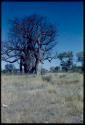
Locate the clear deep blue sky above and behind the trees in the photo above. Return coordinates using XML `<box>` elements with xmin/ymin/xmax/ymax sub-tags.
<box><xmin>1</xmin><ymin>2</ymin><xmax>83</xmax><ymax>69</ymax></box>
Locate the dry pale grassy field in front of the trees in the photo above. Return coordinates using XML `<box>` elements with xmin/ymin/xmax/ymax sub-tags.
<box><xmin>1</xmin><ymin>73</ymin><xmax>83</xmax><ymax>123</ymax></box>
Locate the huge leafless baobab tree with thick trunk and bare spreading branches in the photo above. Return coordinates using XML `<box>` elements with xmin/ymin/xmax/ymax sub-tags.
<box><xmin>2</xmin><ymin>15</ymin><xmax>57</xmax><ymax>73</ymax></box>
